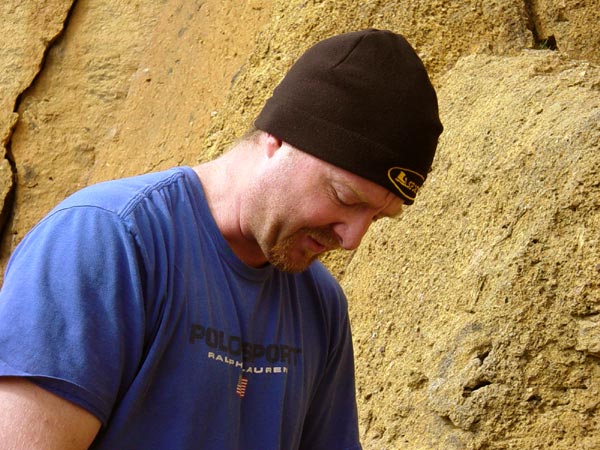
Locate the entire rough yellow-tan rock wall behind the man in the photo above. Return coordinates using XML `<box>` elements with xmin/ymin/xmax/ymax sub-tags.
<box><xmin>0</xmin><ymin>0</ymin><xmax>600</xmax><ymax>450</ymax></box>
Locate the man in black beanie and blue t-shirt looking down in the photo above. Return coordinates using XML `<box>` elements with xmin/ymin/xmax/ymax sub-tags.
<box><xmin>0</xmin><ymin>30</ymin><xmax>442</xmax><ymax>450</ymax></box>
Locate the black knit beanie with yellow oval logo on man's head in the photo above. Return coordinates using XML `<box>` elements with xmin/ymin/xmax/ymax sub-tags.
<box><xmin>255</xmin><ymin>29</ymin><xmax>443</xmax><ymax>205</ymax></box>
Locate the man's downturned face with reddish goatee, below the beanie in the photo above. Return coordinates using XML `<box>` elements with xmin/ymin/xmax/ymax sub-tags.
<box><xmin>248</xmin><ymin>143</ymin><xmax>403</xmax><ymax>272</ymax></box>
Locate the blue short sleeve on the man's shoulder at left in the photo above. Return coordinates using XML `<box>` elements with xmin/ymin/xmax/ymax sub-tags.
<box><xmin>0</xmin><ymin>206</ymin><xmax>144</xmax><ymax>423</ymax></box>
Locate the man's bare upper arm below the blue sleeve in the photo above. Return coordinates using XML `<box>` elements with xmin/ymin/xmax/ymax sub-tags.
<box><xmin>0</xmin><ymin>378</ymin><xmax>100</xmax><ymax>450</ymax></box>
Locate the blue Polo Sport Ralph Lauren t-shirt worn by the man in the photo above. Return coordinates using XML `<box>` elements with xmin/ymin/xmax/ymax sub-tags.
<box><xmin>0</xmin><ymin>167</ymin><xmax>360</xmax><ymax>450</ymax></box>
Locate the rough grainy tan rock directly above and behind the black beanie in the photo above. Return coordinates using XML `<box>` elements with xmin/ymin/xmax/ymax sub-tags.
<box><xmin>206</xmin><ymin>0</ymin><xmax>533</xmax><ymax>158</ymax></box>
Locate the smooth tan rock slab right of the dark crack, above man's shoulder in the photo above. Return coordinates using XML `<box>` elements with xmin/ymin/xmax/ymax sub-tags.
<box><xmin>4</xmin><ymin>0</ymin><xmax>269</xmax><ymax>264</ymax></box>
